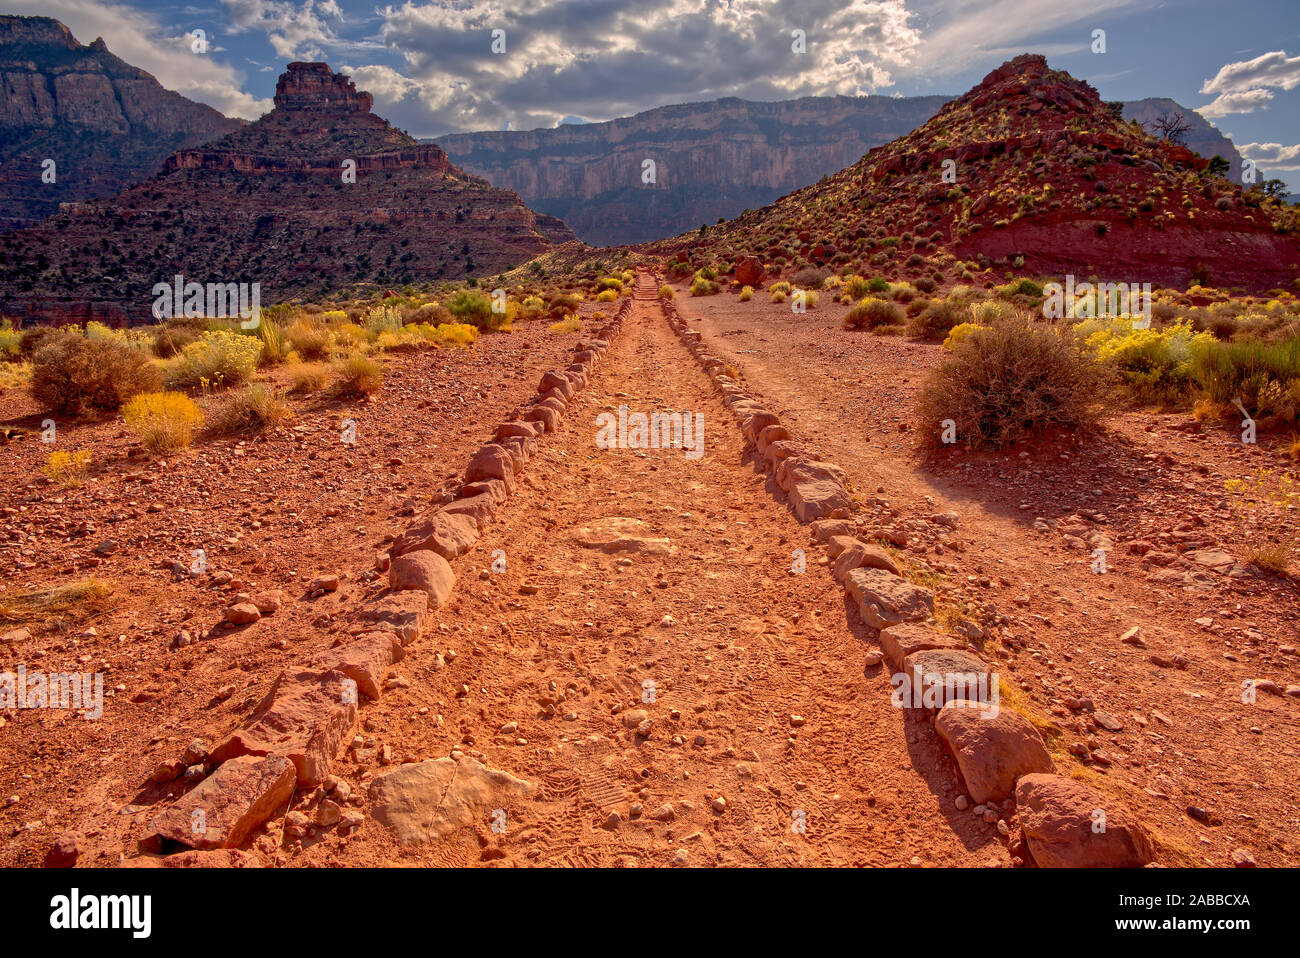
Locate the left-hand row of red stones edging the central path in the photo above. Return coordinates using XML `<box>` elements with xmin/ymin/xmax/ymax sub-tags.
<box><xmin>135</xmin><ymin>298</ymin><xmax>632</xmax><ymax>864</ymax></box>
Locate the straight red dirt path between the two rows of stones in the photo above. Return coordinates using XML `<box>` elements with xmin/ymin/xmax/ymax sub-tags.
<box><xmin>322</xmin><ymin>270</ymin><xmax>993</xmax><ymax>866</ymax></box>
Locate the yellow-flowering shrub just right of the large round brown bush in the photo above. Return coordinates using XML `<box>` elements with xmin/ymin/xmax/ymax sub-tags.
<box><xmin>1074</xmin><ymin>320</ymin><xmax>1213</xmax><ymax>402</ymax></box>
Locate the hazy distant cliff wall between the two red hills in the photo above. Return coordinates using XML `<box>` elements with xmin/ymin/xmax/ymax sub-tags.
<box><xmin>437</xmin><ymin>96</ymin><xmax>948</xmax><ymax>246</ymax></box>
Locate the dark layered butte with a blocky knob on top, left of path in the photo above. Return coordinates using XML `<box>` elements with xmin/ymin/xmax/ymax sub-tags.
<box><xmin>0</xmin><ymin>64</ymin><xmax>573</xmax><ymax>322</ymax></box>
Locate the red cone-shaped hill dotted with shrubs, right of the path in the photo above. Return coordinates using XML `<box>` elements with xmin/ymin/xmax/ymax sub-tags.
<box><xmin>660</xmin><ymin>55</ymin><xmax>1300</xmax><ymax>290</ymax></box>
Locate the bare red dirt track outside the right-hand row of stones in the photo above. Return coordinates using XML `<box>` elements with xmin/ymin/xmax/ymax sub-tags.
<box><xmin>680</xmin><ymin>287</ymin><xmax>1300</xmax><ymax>866</ymax></box>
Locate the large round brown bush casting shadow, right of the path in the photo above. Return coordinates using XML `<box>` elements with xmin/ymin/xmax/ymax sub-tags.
<box><xmin>918</xmin><ymin>316</ymin><xmax>1102</xmax><ymax>448</ymax></box>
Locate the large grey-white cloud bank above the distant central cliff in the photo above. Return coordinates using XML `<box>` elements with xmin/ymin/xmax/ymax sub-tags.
<box><xmin>374</xmin><ymin>0</ymin><xmax>920</xmax><ymax>133</ymax></box>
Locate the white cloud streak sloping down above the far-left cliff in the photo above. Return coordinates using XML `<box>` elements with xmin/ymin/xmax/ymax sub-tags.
<box><xmin>5</xmin><ymin>0</ymin><xmax>272</xmax><ymax>120</ymax></box>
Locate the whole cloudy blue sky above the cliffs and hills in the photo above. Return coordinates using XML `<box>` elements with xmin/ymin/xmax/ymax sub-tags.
<box><xmin>10</xmin><ymin>0</ymin><xmax>1300</xmax><ymax>192</ymax></box>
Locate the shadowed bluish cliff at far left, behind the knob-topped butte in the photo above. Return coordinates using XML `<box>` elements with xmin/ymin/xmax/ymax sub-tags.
<box><xmin>0</xmin><ymin>16</ymin><xmax>242</xmax><ymax>231</ymax></box>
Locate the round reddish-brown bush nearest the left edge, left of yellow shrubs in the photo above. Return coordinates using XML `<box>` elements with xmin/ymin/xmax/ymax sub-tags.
<box><xmin>31</xmin><ymin>331</ymin><xmax>163</xmax><ymax>415</ymax></box>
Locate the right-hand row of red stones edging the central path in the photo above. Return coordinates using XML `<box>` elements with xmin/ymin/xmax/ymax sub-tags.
<box><xmin>660</xmin><ymin>293</ymin><xmax>1153</xmax><ymax>867</ymax></box>
